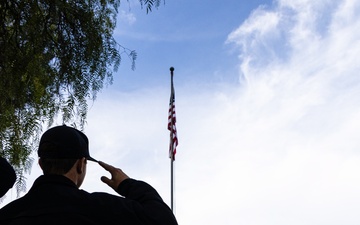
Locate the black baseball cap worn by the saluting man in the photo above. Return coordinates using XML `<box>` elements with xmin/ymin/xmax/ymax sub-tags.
<box><xmin>38</xmin><ymin>125</ymin><xmax>97</xmax><ymax>162</ymax></box>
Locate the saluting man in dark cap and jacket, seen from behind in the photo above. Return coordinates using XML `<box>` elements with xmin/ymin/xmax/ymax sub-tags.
<box><xmin>0</xmin><ymin>126</ymin><xmax>177</xmax><ymax>225</ymax></box>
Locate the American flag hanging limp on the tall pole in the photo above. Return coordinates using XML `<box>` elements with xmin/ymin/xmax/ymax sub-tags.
<box><xmin>168</xmin><ymin>73</ymin><xmax>178</xmax><ymax>160</ymax></box>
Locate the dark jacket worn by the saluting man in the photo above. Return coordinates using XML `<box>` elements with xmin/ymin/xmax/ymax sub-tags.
<box><xmin>0</xmin><ymin>175</ymin><xmax>177</xmax><ymax>225</ymax></box>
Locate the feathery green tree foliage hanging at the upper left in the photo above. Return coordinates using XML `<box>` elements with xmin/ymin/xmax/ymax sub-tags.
<box><xmin>0</xmin><ymin>0</ymin><xmax>159</xmax><ymax>194</ymax></box>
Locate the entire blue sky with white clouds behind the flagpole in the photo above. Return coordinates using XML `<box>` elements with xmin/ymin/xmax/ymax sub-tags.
<box><xmin>0</xmin><ymin>0</ymin><xmax>360</xmax><ymax>225</ymax></box>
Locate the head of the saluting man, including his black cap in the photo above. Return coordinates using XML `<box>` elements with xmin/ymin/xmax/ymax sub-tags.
<box><xmin>38</xmin><ymin>125</ymin><xmax>97</xmax><ymax>186</ymax></box>
